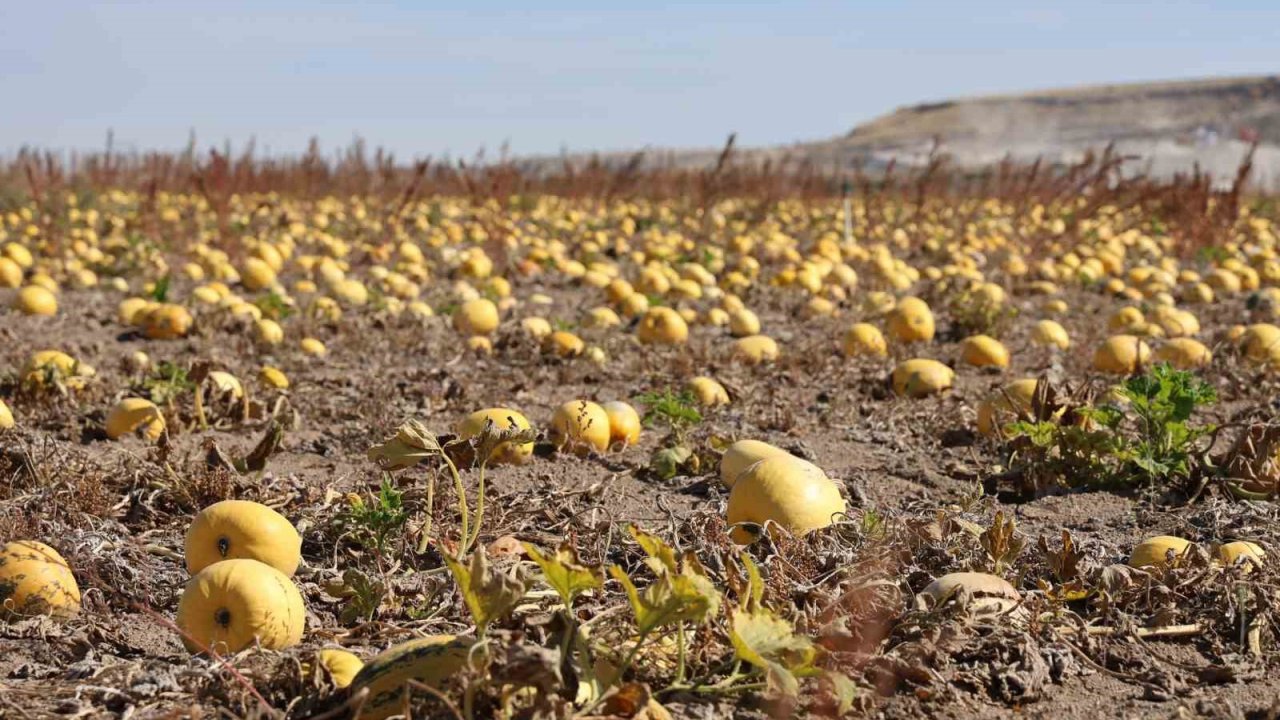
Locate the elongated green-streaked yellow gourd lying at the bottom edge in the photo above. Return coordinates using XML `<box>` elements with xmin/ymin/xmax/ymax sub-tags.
<box><xmin>351</xmin><ymin>635</ymin><xmax>475</xmax><ymax>720</ymax></box>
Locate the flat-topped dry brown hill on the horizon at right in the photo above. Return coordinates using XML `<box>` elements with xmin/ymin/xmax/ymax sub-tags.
<box><xmin>540</xmin><ymin>76</ymin><xmax>1280</xmax><ymax>190</ymax></box>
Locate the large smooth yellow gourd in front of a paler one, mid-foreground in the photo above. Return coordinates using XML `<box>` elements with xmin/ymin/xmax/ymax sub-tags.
<box><xmin>727</xmin><ymin>455</ymin><xmax>846</xmax><ymax>544</ymax></box>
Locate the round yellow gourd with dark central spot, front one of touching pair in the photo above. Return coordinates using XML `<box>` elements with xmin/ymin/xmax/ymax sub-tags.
<box><xmin>175</xmin><ymin>559</ymin><xmax>306</xmax><ymax>655</ymax></box>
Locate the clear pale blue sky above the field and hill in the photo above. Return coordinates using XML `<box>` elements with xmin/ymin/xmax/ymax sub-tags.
<box><xmin>0</xmin><ymin>0</ymin><xmax>1280</xmax><ymax>158</ymax></box>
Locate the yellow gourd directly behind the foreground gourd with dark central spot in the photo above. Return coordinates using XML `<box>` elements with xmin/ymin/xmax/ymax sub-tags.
<box><xmin>184</xmin><ymin>500</ymin><xmax>302</xmax><ymax>575</ymax></box>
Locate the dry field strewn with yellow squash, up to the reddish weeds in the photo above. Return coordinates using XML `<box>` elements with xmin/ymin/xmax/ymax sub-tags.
<box><xmin>0</xmin><ymin>154</ymin><xmax>1280</xmax><ymax>720</ymax></box>
